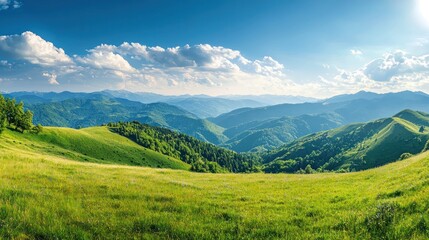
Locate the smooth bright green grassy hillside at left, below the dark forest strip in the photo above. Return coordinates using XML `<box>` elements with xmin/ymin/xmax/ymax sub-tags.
<box><xmin>0</xmin><ymin>127</ymin><xmax>190</xmax><ymax>170</ymax></box>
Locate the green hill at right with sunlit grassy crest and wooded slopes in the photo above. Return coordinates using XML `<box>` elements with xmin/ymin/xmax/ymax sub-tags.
<box><xmin>264</xmin><ymin>110</ymin><xmax>429</xmax><ymax>172</ymax></box>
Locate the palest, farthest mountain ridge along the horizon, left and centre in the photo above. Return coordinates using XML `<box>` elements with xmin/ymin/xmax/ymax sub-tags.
<box><xmin>5</xmin><ymin>90</ymin><xmax>317</xmax><ymax>118</ymax></box>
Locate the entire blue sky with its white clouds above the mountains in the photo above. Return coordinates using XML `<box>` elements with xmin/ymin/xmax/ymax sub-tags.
<box><xmin>0</xmin><ymin>0</ymin><xmax>429</xmax><ymax>97</ymax></box>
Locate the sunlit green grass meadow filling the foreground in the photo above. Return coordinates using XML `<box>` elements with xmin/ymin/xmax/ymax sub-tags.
<box><xmin>0</xmin><ymin>129</ymin><xmax>429</xmax><ymax>239</ymax></box>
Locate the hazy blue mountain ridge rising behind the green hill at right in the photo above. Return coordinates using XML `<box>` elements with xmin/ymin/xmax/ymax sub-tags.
<box><xmin>211</xmin><ymin>91</ymin><xmax>429</xmax><ymax>128</ymax></box>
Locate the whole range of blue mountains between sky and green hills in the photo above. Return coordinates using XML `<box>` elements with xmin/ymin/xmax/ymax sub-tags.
<box><xmin>6</xmin><ymin>91</ymin><xmax>429</xmax><ymax>152</ymax></box>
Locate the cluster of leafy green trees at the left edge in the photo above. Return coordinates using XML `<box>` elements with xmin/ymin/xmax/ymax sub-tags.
<box><xmin>0</xmin><ymin>94</ymin><xmax>42</xmax><ymax>133</ymax></box>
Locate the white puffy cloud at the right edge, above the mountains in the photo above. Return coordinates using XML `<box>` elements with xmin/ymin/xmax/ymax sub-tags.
<box><xmin>319</xmin><ymin>50</ymin><xmax>429</xmax><ymax>94</ymax></box>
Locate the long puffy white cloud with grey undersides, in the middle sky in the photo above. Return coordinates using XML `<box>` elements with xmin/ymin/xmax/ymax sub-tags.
<box><xmin>90</xmin><ymin>42</ymin><xmax>284</xmax><ymax>76</ymax></box>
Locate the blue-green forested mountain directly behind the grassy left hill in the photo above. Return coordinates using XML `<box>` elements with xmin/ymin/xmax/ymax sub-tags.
<box><xmin>27</xmin><ymin>94</ymin><xmax>226</xmax><ymax>144</ymax></box>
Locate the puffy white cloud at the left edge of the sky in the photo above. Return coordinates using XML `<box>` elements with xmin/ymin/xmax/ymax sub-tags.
<box><xmin>0</xmin><ymin>32</ymin><xmax>73</xmax><ymax>66</ymax></box>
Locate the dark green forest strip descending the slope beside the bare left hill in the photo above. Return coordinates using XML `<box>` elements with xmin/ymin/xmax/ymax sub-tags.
<box><xmin>108</xmin><ymin>122</ymin><xmax>260</xmax><ymax>172</ymax></box>
